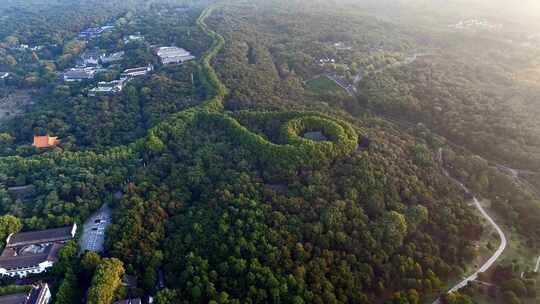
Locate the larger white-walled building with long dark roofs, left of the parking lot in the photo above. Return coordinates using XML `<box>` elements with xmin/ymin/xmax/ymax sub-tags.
<box><xmin>0</xmin><ymin>224</ymin><xmax>77</xmax><ymax>278</ymax></box>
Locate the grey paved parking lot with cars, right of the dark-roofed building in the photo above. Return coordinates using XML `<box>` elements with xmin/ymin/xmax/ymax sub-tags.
<box><xmin>79</xmin><ymin>204</ymin><xmax>112</xmax><ymax>252</ymax></box>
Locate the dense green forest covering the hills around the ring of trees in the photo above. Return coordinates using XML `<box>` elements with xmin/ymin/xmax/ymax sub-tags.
<box><xmin>0</xmin><ymin>0</ymin><xmax>540</xmax><ymax>304</ymax></box>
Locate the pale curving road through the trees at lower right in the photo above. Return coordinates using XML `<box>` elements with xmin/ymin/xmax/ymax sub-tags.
<box><xmin>433</xmin><ymin>149</ymin><xmax>508</xmax><ymax>304</ymax></box>
